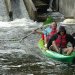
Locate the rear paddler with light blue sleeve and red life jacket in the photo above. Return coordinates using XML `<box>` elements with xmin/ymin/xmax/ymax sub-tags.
<box><xmin>35</xmin><ymin>22</ymin><xmax>57</xmax><ymax>47</ymax></box>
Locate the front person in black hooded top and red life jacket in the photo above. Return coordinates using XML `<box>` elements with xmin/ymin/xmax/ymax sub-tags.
<box><xmin>47</xmin><ymin>26</ymin><xmax>75</xmax><ymax>55</ymax></box>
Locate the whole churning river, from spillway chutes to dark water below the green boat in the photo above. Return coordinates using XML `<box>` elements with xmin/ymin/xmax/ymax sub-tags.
<box><xmin>0</xmin><ymin>0</ymin><xmax>75</xmax><ymax>75</ymax></box>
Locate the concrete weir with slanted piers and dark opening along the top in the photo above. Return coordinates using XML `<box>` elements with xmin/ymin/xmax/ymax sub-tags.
<box><xmin>4</xmin><ymin>0</ymin><xmax>75</xmax><ymax>21</ymax></box>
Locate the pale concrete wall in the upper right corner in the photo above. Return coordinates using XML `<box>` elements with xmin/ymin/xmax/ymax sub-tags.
<box><xmin>59</xmin><ymin>0</ymin><xmax>75</xmax><ymax>18</ymax></box>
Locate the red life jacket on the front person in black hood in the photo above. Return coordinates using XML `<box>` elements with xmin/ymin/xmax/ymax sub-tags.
<box><xmin>55</xmin><ymin>34</ymin><xmax>67</xmax><ymax>48</ymax></box>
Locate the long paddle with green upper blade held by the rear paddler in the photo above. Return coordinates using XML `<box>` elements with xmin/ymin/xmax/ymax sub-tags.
<box><xmin>20</xmin><ymin>16</ymin><xmax>53</xmax><ymax>42</ymax></box>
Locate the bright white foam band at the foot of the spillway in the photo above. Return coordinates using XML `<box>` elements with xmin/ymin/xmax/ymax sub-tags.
<box><xmin>0</xmin><ymin>18</ymin><xmax>40</xmax><ymax>28</ymax></box>
